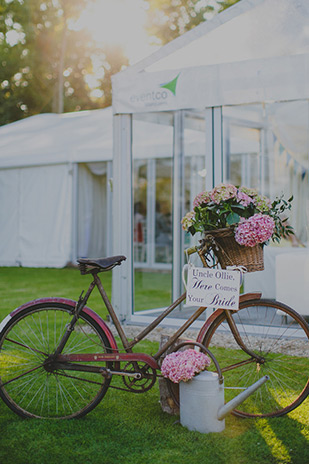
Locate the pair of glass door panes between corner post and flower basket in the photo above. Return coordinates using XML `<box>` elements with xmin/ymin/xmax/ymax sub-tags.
<box><xmin>132</xmin><ymin>110</ymin><xmax>213</xmax><ymax>317</ymax></box>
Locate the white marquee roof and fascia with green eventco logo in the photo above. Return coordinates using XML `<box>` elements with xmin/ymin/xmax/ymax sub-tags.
<box><xmin>112</xmin><ymin>0</ymin><xmax>309</xmax><ymax>114</ymax></box>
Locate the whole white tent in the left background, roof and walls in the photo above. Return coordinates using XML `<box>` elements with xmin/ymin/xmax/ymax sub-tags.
<box><xmin>0</xmin><ymin>109</ymin><xmax>112</xmax><ymax>267</ymax></box>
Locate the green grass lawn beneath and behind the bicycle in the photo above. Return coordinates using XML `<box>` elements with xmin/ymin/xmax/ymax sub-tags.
<box><xmin>0</xmin><ymin>268</ymin><xmax>309</xmax><ymax>464</ymax></box>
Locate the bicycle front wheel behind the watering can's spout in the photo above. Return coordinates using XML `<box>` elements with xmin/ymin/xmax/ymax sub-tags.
<box><xmin>200</xmin><ymin>299</ymin><xmax>309</xmax><ymax>417</ymax></box>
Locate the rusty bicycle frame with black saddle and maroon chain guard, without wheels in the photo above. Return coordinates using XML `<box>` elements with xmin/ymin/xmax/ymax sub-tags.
<box><xmin>45</xmin><ymin>246</ymin><xmax>263</xmax><ymax>391</ymax></box>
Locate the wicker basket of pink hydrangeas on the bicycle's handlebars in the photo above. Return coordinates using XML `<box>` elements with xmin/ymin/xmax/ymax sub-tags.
<box><xmin>181</xmin><ymin>184</ymin><xmax>294</xmax><ymax>272</ymax></box>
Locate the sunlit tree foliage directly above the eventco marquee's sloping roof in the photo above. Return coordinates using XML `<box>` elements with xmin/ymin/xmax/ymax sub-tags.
<box><xmin>147</xmin><ymin>0</ymin><xmax>239</xmax><ymax>45</ymax></box>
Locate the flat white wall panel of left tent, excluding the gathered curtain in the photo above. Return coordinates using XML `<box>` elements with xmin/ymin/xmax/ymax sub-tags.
<box><xmin>0</xmin><ymin>165</ymin><xmax>72</xmax><ymax>267</ymax></box>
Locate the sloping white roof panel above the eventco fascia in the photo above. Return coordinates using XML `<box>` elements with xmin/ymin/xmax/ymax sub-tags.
<box><xmin>139</xmin><ymin>0</ymin><xmax>309</xmax><ymax>72</ymax></box>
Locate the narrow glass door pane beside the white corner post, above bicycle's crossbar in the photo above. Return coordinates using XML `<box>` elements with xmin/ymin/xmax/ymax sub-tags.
<box><xmin>132</xmin><ymin>114</ymin><xmax>173</xmax><ymax>311</ymax></box>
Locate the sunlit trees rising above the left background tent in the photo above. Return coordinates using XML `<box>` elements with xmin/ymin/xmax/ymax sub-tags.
<box><xmin>0</xmin><ymin>0</ymin><xmax>127</xmax><ymax>125</ymax></box>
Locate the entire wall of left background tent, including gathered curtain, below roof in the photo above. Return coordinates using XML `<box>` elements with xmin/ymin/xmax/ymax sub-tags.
<box><xmin>0</xmin><ymin>162</ymin><xmax>112</xmax><ymax>267</ymax></box>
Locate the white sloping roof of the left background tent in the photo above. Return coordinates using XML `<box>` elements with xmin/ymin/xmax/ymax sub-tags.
<box><xmin>0</xmin><ymin>108</ymin><xmax>113</xmax><ymax>168</ymax></box>
